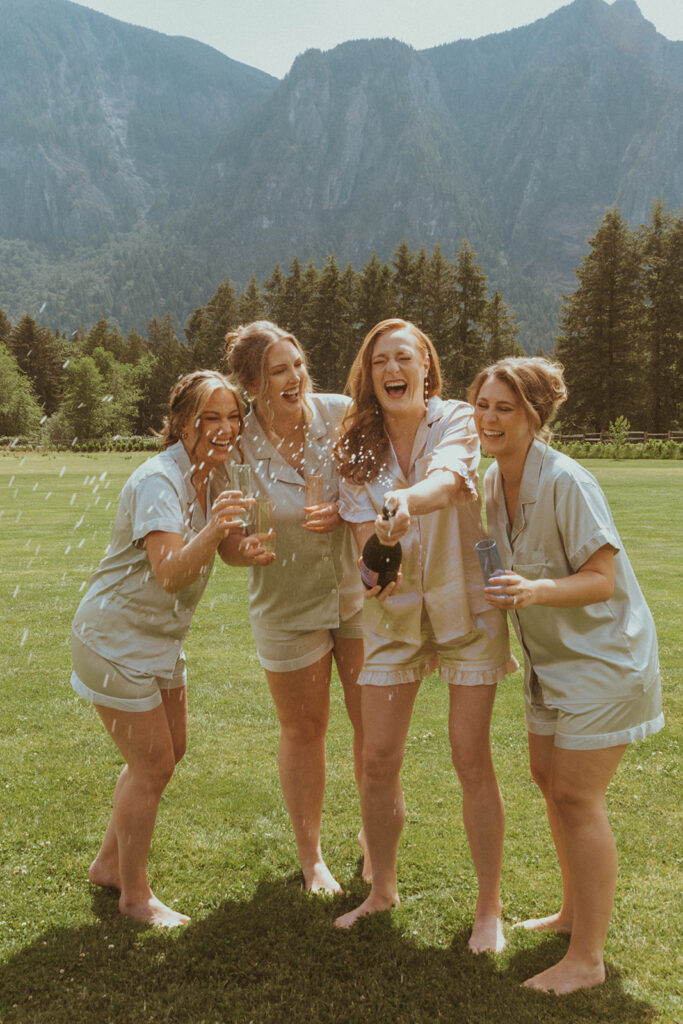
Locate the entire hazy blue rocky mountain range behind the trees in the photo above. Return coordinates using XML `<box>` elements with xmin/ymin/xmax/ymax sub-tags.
<box><xmin>0</xmin><ymin>0</ymin><xmax>683</xmax><ymax>347</ymax></box>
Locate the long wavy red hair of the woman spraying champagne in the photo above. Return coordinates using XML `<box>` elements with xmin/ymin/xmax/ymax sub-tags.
<box><xmin>335</xmin><ymin>317</ymin><xmax>441</xmax><ymax>483</ymax></box>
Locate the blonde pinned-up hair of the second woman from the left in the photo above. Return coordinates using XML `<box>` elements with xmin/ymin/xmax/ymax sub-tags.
<box><xmin>225</xmin><ymin>321</ymin><xmax>313</xmax><ymax>433</ymax></box>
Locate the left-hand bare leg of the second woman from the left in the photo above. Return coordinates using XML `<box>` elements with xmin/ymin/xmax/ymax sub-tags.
<box><xmin>265</xmin><ymin>652</ymin><xmax>341</xmax><ymax>893</ymax></box>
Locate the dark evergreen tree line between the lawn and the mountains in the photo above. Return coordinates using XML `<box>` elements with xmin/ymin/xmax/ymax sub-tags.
<box><xmin>0</xmin><ymin>203</ymin><xmax>683</xmax><ymax>443</ymax></box>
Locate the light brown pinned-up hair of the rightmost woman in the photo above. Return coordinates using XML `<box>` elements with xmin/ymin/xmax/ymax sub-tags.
<box><xmin>467</xmin><ymin>355</ymin><xmax>567</xmax><ymax>441</ymax></box>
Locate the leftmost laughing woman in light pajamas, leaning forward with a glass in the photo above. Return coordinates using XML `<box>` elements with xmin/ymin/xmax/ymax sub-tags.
<box><xmin>72</xmin><ymin>371</ymin><xmax>269</xmax><ymax>927</ymax></box>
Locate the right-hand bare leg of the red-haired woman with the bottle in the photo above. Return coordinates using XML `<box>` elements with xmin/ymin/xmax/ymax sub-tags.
<box><xmin>449</xmin><ymin>686</ymin><xmax>505</xmax><ymax>953</ymax></box>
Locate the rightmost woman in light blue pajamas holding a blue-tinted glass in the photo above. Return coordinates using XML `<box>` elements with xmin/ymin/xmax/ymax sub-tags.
<box><xmin>468</xmin><ymin>357</ymin><xmax>664</xmax><ymax>992</ymax></box>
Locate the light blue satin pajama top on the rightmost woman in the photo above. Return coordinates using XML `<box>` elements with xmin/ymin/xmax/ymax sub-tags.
<box><xmin>484</xmin><ymin>439</ymin><xmax>664</xmax><ymax>731</ymax></box>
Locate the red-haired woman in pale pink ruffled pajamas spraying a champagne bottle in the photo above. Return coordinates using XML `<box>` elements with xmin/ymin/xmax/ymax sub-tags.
<box><xmin>337</xmin><ymin>319</ymin><xmax>517</xmax><ymax>952</ymax></box>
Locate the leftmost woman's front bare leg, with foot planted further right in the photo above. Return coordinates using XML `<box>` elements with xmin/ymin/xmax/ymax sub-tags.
<box><xmin>95</xmin><ymin>687</ymin><xmax>189</xmax><ymax>927</ymax></box>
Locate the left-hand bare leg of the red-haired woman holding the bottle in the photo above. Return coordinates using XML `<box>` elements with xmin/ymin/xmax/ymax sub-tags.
<box><xmin>335</xmin><ymin>679</ymin><xmax>420</xmax><ymax>928</ymax></box>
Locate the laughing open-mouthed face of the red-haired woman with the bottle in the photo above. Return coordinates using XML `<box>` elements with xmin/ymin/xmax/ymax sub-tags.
<box><xmin>371</xmin><ymin>328</ymin><xmax>429</xmax><ymax>416</ymax></box>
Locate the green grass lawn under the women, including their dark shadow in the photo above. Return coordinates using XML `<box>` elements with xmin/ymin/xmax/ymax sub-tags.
<box><xmin>0</xmin><ymin>454</ymin><xmax>683</xmax><ymax>1024</ymax></box>
